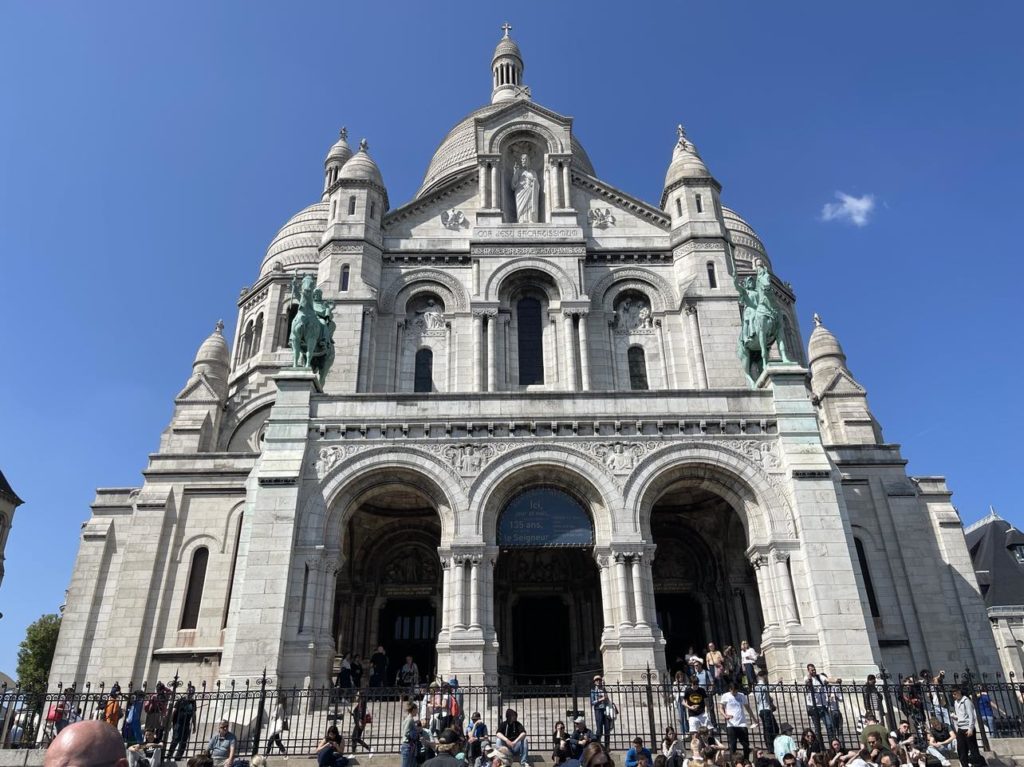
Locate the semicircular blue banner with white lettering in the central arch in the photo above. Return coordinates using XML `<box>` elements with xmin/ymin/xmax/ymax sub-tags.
<box><xmin>498</xmin><ymin>487</ymin><xmax>594</xmax><ymax>548</ymax></box>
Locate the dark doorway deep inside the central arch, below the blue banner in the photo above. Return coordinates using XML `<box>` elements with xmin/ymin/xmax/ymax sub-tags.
<box><xmin>512</xmin><ymin>596</ymin><xmax>572</xmax><ymax>684</ymax></box>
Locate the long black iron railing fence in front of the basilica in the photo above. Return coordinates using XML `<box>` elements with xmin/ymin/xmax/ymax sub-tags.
<box><xmin>0</xmin><ymin>671</ymin><xmax>1024</xmax><ymax>759</ymax></box>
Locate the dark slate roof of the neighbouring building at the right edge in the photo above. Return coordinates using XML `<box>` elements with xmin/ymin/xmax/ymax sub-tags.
<box><xmin>965</xmin><ymin>510</ymin><xmax>1024</xmax><ymax>607</ymax></box>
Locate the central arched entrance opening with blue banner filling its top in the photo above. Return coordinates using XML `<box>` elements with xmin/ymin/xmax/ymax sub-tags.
<box><xmin>495</xmin><ymin>486</ymin><xmax>602</xmax><ymax>684</ymax></box>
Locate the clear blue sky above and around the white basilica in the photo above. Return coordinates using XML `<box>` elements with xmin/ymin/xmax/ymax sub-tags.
<box><xmin>0</xmin><ymin>0</ymin><xmax>1024</xmax><ymax>673</ymax></box>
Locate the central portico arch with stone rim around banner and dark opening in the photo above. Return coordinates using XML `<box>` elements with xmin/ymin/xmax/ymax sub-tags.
<box><xmin>476</xmin><ymin>460</ymin><xmax>609</xmax><ymax>683</ymax></box>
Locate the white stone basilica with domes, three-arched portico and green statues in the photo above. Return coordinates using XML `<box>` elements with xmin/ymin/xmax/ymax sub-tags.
<box><xmin>51</xmin><ymin>28</ymin><xmax>997</xmax><ymax>685</ymax></box>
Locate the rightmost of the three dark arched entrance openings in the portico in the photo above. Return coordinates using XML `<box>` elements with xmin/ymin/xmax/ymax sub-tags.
<box><xmin>650</xmin><ymin>479</ymin><xmax>764</xmax><ymax>673</ymax></box>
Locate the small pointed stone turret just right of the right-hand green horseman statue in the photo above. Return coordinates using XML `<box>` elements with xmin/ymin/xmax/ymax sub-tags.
<box><xmin>807</xmin><ymin>313</ymin><xmax>883</xmax><ymax>444</ymax></box>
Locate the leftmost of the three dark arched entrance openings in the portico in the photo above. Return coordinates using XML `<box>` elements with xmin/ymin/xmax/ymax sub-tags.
<box><xmin>334</xmin><ymin>482</ymin><xmax>441</xmax><ymax>683</ymax></box>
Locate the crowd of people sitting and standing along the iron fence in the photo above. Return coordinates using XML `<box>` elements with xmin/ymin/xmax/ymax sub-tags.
<box><xmin>25</xmin><ymin>642</ymin><xmax>1002</xmax><ymax>767</ymax></box>
